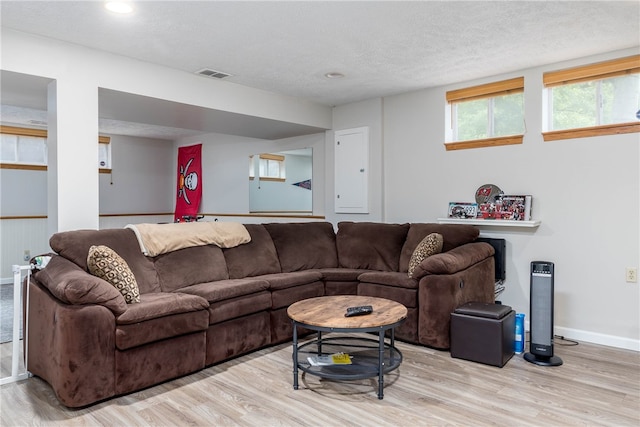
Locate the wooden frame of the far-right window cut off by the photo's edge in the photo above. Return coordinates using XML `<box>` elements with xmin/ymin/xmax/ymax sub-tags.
<box><xmin>542</xmin><ymin>55</ymin><xmax>640</xmax><ymax>141</ymax></box>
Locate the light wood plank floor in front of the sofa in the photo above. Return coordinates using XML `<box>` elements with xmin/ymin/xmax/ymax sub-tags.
<box><xmin>0</xmin><ymin>341</ymin><xmax>640</xmax><ymax>426</ymax></box>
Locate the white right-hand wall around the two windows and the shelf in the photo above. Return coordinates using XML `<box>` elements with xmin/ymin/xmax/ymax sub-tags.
<box><xmin>376</xmin><ymin>51</ymin><xmax>640</xmax><ymax>350</ymax></box>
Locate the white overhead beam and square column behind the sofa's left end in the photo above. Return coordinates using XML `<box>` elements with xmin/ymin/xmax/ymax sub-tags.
<box><xmin>1</xmin><ymin>28</ymin><xmax>331</xmax><ymax>232</ymax></box>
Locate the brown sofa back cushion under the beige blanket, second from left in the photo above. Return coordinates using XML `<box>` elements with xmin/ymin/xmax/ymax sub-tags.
<box><xmin>154</xmin><ymin>245</ymin><xmax>229</xmax><ymax>292</ymax></box>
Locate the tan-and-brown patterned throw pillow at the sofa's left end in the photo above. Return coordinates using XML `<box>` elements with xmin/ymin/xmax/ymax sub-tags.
<box><xmin>87</xmin><ymin>246</ymin><xmax>140</xmax><ymax>304</ymax></box>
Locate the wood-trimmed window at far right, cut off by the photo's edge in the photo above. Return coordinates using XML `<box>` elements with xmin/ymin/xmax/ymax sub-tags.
<box><xmin>543</xmin><ymin>55</ymin><xmax>640</xmax><ymax>141</ymax></box>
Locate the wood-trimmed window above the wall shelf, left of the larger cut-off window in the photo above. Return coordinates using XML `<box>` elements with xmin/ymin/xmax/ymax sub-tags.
<box><xmin>445</xmin><ymin>77</ymin><xmax>524</xmax><ymax>150</ymax></box>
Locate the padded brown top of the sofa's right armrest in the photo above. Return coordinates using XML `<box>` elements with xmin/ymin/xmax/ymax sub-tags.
<box><xmin>413</xmin><ymin>242</ymin><xmax>495</xmax><ymax>280</ymax></box>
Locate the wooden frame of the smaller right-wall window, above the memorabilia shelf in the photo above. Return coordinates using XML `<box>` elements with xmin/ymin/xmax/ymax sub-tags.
<box><xmin>444</xmin><ymin>77</ymin><xmax>524</xmax><ymax>151</ymax></box>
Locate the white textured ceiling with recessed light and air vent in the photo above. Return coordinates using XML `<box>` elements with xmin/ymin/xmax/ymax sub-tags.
<box><xmin>0</xmin><ymin>0</ymin><xmax>640</xmax><ymax>140</ymax></box>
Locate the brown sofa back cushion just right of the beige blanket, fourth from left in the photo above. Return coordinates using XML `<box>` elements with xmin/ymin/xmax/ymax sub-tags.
<box><xmin>264</xmin><ymin>222</ymin><xmax>338</xmax><ymax>273</ymax></box>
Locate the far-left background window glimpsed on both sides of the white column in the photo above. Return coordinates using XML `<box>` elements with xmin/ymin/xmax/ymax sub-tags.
<box><xmin>0</xmin><ymin>126</ymin><xmax>111</xmax><ymax>173</ymax></box>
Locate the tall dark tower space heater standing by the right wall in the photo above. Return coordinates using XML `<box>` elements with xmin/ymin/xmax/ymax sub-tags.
<box><xmin>524</xmin><ymin>261</ymin><xmax>562</xmax><ymax>366</ymax></box>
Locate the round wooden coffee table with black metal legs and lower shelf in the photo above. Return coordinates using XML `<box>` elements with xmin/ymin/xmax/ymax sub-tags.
<box><xmin>287</xmin><ymin>295</ymin><xmax>407</xmax><ymax>399</ymax></box>
